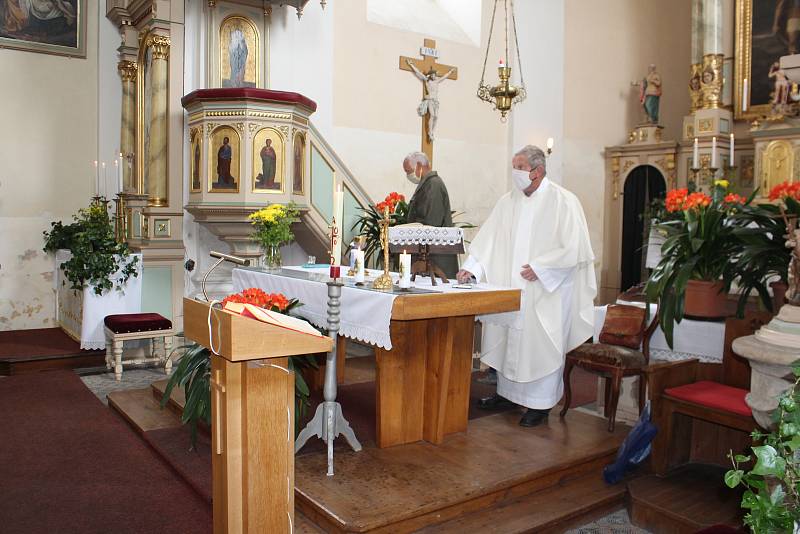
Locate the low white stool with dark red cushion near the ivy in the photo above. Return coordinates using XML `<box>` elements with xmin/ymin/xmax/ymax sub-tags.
<box><xmin>104</xmin><ymin>313</ymin><xmax>175</xmax><ymax>380</ymax></box>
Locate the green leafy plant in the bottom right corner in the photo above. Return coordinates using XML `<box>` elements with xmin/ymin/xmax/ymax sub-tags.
<box><xmin>725</xmin><ymin>361</ymin><xmax>800</xmax><ymax>533</ymax></box>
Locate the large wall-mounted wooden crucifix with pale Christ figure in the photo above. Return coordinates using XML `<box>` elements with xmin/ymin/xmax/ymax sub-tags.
<box><xmin>400</xmin><ymin>39</ymin><xmax>458</xmax><ymax>162</ymax></box>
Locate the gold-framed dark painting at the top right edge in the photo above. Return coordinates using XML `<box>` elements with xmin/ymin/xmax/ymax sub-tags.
<box><xmin>734</xmin><ymin>0</ymin><xmax>800</xmax><ymax>119</ymax></box>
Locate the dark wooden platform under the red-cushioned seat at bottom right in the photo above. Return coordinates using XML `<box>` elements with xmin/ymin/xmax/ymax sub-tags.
<box><xmin>628</xmin><ymin>464</ymin><xmax>742</xmax><ymax>534</ymax></box>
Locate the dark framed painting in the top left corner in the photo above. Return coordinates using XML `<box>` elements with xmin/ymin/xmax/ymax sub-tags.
<box><xmin>0</xmin><ymin>0</ymin><xmax>86</xmax><ymax>58</ymax></box>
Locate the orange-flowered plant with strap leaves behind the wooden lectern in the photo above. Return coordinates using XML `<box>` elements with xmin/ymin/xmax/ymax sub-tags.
<box><xmin>161</xmin><ymin>288</ymin><xmax>317</xmax><ymax>447</ymax></box>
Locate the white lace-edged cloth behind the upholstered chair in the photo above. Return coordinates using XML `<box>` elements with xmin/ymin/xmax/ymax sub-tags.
<box><xmin>594</xmin><ymin>301</ymin><xmax>725</xmax><ymax>363</ymax></box>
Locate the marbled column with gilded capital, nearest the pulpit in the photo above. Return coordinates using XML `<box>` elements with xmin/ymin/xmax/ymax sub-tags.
<box><xmin>145</xmin><ymin>35</ymin><xmax>170</xmax><ymax>206</ymax></box>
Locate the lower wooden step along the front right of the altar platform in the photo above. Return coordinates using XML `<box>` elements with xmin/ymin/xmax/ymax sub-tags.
<box><xmin>417</xmin><ymin>473</ymin><xmax>625</xmax><ymax>534</ymax></box>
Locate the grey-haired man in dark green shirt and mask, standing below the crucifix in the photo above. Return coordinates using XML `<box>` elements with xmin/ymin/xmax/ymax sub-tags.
<box><xmin>403</xmin><ymin>152</ymin><xmax>458</xmax><ymax>279</ymax></box>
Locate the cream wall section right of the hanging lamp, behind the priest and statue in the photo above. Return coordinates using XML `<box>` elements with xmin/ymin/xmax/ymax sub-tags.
<box><xmin>556</xmin><ymin>0</ymin><xmax>691</xmax><ymax>282</ymax></box>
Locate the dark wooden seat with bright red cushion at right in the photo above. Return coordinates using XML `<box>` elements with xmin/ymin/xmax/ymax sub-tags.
<box><xmin>645</xmin><ymin>312</ymin><xmax>772</xmax><ymax>475</ymax></box>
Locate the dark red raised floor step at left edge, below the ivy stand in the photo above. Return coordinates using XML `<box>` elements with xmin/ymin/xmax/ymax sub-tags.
<box><xmin>0</xmin><ymin>328</ymin><xmax>106</xmax><ymax>375</ymax></box>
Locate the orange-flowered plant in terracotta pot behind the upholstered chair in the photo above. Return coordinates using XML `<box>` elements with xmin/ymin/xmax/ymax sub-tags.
<box><xmin>645</xmin><ymin>180</ymin><xmax>751</xmax><ymax>347</ymax></box>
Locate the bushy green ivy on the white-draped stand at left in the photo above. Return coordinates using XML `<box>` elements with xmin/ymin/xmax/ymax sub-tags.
<box><xmin>44</xmin><ymin>201</ymin><xmax>139</xmax><ymax>295</ymax></box>
